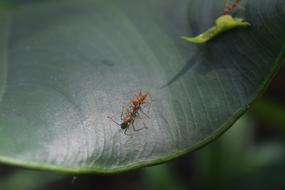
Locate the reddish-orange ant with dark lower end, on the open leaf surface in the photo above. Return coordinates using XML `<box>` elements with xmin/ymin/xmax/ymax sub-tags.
<box><xmin>108</xmin><ymin>91</ymin><xmax>150</xmax><ymax>135</ymax></box>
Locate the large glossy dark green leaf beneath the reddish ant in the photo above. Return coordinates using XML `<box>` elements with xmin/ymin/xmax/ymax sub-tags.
<box><xmin>0</xmin><ymin>0</ymin><xmax>285</xmax><ymax>173</ymax></box>
